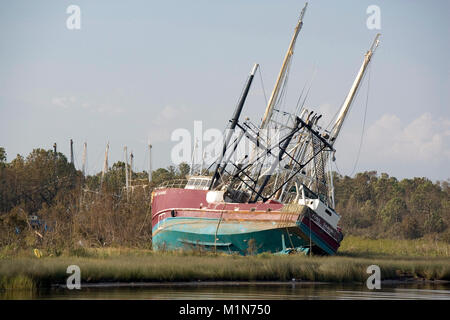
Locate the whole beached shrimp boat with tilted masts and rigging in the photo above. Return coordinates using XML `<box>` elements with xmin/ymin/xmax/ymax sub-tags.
<box><xmin>152</xmin><ymin>1</ymin><xmax>379</xmax><ymax>255</ymax></box>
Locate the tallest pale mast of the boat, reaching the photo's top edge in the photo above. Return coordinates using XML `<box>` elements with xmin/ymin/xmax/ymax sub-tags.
<box><xmin>261</xmin><ymin>2</ymin><xmax>308</xmax><ymax>129</ymax></box>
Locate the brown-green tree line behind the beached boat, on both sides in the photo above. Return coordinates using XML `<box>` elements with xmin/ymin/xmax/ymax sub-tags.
<box><xmin>0</xmin><ymin>147</ymin><xmax>450</xmax><ymax>253</ymax></box>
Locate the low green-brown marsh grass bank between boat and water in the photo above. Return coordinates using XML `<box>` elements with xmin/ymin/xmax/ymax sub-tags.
<box><xmin>0</xmin><ymin>242</ymin><xmax>450</xmax><ymax>289</ymax></box>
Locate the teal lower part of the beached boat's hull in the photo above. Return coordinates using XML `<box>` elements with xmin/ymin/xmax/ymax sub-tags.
<box><xmin>152</xmin><ymin>217</ymin><xmax>320</xmax><ymax>255</ymax></box>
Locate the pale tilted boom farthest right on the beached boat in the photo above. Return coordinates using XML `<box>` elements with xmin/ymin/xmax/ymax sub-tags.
<box><xmin>330</xmin><ymin>33</ymin><xmax>381</xmax><ymax>145</ymax></box>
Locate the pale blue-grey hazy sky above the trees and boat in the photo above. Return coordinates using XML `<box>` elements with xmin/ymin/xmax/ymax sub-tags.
<box><xmin>0</xmin><ymin>0</ymin><xmax>450</xmax><ymax>181</ymax></box>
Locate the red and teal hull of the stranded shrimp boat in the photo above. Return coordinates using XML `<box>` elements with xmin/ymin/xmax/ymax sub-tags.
<box><xmin>152</xmin><ymin>189</ymin><xmax>341</xmax><ymax>255</ymax></box>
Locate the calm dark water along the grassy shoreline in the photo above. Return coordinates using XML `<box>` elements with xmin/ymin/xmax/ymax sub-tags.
<box><xmin>0</xmin><ymin>282</ymin><xmax>450</xmax><ymax>300</ymax></box>
